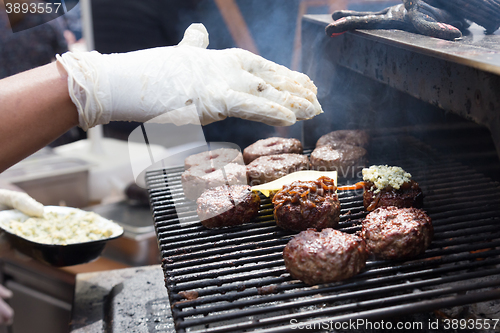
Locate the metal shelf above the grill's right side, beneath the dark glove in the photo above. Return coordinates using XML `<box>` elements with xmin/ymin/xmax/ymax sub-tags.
<box><xmin>302</xmin><ymin>15</ymin><xmax>500</xmax><ymax>153</ymax></box>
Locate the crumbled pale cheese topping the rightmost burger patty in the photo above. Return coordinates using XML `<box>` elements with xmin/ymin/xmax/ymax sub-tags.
<box><xmin>362</xmin><ymin>165</ymin><xmax>411</xmax><ymax>194</ymax></box>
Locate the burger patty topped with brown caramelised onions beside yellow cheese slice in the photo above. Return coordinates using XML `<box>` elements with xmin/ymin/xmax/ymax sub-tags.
<box><xmin>273</xmin><ymin>177</ymin><xmax>340</xmax><ymax>231</ymax></box>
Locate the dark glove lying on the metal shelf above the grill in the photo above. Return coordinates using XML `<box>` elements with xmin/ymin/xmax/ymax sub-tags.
<box><xmin>326</xmin><ymin>0</ymin><xmax>468</xmax><ymax>40</ymax></box>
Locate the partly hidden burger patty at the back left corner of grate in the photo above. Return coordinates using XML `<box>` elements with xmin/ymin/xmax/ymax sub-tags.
<box><xmin>184</xmin><ymin>148</ymin><xmax>243</xmax><ymax>169</ymax></box>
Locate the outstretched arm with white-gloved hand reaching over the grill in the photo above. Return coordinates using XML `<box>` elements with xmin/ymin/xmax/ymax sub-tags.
<box><xmin>0</xmin><ymin>25</ymin><xmax>322</xmax><ymax>172</ymax></box>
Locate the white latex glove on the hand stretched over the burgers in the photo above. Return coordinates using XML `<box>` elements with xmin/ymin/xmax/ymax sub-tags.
<box><xmin>57</xmin><ymin>24</ymin><xmax>323</xmax><ymax>130</ymax></box>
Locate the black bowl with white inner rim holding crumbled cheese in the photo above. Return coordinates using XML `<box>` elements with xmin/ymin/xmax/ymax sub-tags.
<box><xmin>0</xmin><ymin>206</ymin><xmax>123</xmax><ymax>267</ymax></box>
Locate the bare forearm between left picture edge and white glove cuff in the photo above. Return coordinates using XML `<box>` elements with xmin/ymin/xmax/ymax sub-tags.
<box><xmin>0</xmin><ymin>63</ymin><xmax>78</xmax><ymax>172</ymax></box>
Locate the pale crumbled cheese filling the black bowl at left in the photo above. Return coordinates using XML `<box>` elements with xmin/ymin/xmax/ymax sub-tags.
<box><xmin>0</xmin><ymin>207</ymin><xmax>123</xmax><ymax>245</ymax></box>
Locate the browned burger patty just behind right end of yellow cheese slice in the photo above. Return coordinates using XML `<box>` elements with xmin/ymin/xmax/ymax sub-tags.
<box><xmin>311</xmin><ymin>144</ymin><xmax>367</xmax><ymax>178</ymax></box>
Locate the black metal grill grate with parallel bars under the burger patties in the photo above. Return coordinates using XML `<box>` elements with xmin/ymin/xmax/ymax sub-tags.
<box><xmin>146</xmin><ymin>137</ymin><xmax>500</xmax><ymax>332</ymax></box>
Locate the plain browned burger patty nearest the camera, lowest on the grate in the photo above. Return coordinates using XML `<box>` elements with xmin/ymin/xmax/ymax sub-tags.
<box><xmin>283</xmin><ymin>228</ymin><xmax>367</xmax><ymax>285</ymax></box>
